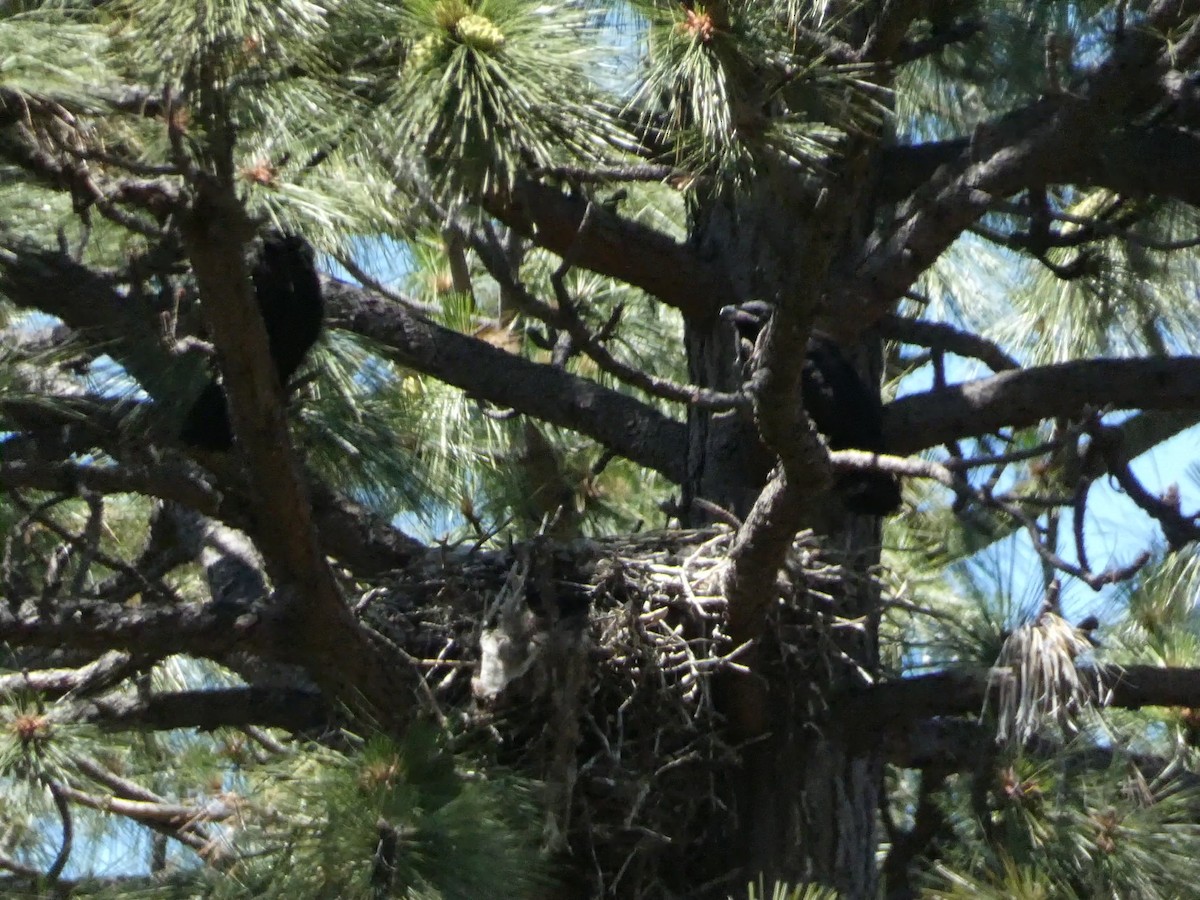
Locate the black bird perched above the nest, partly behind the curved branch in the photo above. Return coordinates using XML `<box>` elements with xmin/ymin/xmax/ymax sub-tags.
<box><xmin>721</xmin><ymin>301</ymin><xmax>900</xmax><ymax>516</ymax></box>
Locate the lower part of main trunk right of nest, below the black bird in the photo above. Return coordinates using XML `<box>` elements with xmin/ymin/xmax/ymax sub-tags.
<box><xmin>716</xmin><ymin>516</ymin><xmax>883</xmax><ymax>900</ymax></box>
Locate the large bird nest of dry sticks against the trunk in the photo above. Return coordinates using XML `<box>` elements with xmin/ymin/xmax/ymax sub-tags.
<box><xmin>360</xmin><ymin>528</ymin><xmax>845</xmax><ymax>898</ymax></box>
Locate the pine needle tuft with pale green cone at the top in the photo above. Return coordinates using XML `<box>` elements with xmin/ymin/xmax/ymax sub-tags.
<box><xmin>377</xmin><ymin>0</ymin><xmax>628</xmax><ymax>198</ymax></box>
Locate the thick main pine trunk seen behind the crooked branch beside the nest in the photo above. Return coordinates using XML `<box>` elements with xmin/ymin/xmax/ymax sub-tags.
<box><xmin>684</xmin><ymin>176</ymin><xmax>882</xmax><ymax>899</ymax></box>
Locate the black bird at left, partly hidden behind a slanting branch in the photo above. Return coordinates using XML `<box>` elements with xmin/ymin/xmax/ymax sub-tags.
<box><xmin>180</xmin><ymin>232</ymin><xmax>324</xmax><ymax>450</ymax></box>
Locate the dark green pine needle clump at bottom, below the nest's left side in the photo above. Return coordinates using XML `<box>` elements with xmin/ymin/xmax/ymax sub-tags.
<box><xmin>240</xmin><ymin>727</ymin><xmax>546</xmax><ymax>900</ymax></box>
